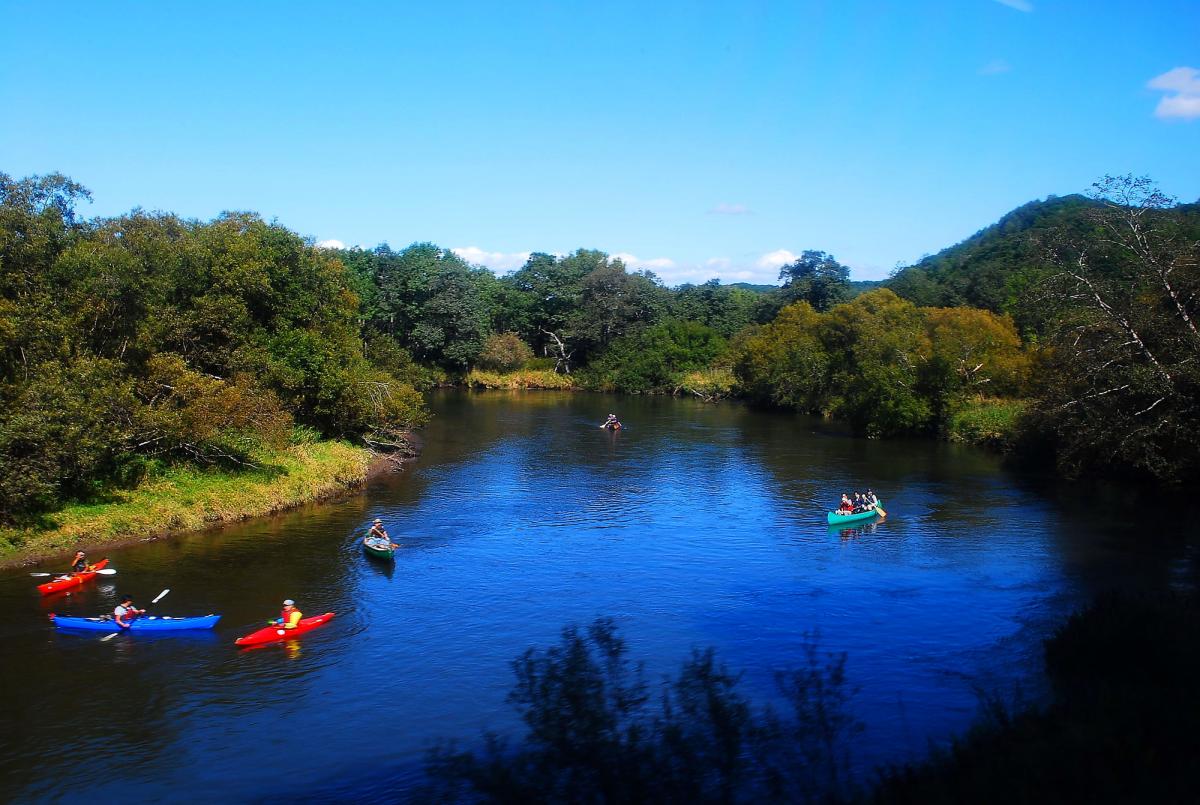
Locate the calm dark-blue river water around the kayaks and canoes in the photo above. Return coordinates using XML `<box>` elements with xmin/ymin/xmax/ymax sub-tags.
<box><xmin>0</xmin><ymin>392</ymin><xmax>1195</xmax><ymax>803</ymax></box>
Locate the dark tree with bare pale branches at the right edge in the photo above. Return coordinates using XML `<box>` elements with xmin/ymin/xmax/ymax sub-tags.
<box><xmin>1031</xmin><ymin>176</ymin><xmax>1200</xmax><ymax>480</ymax></box>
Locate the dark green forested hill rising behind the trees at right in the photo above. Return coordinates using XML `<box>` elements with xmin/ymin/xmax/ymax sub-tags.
<box><xmin>884</xmin><ymin>196</ymin><xmax>1098</xmax><ymax>313</ymax></box>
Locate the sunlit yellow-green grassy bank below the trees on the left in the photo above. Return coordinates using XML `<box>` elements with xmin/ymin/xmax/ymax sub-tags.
<box><xmin>0</xmin><ymin>441</ymin><xmax>372</xmax><ymax>565</ymax></box>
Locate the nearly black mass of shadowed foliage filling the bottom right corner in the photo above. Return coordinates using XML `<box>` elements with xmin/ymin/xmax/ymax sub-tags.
<box><xmin>870</xmin><ymin>595</ymin><xmax>1200</xmax><ymax>805</ymax></box>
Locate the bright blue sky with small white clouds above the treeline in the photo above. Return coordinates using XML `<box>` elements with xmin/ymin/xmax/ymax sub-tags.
<box><xmin>0</xmin><ymin>0</ymin><xmax>1200</xmax><ymax>284</ymax></box>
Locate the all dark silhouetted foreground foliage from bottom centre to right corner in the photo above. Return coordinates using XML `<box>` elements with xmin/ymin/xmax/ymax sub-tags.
<box><xmin>420</xmin><ymin>594</ymin><xmax>1200</xmax><ymax>805</ymax></box>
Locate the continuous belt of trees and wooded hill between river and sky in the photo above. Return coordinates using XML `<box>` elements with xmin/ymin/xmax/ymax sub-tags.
<box><xmin>0</xmin><ymin>174</ymin><xmax>1200</xmax><ymax>561</ymax></box>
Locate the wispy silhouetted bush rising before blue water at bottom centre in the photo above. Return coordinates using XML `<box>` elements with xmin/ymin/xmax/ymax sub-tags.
<box><xmin>422</xmin><ymin>618</ymin><xmax>862</xmax><ymax>803</ymax></box>
